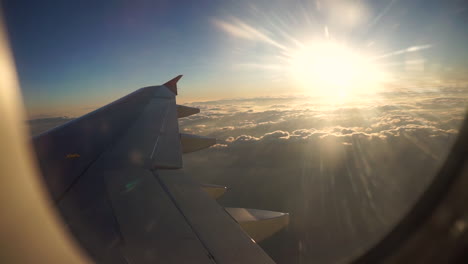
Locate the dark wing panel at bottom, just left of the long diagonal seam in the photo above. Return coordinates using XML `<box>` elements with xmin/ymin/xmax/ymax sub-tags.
<box><xmin>104</xmin><ymin>168</ymin><xmax>212</xmax><ymax>263</ymax></box>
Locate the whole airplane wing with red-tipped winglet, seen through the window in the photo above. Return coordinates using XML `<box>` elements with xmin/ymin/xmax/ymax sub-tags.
<box><xmin>32</xmin><ymin>76</ymin><xmax>289</xmax><ymax>263</ymax></box>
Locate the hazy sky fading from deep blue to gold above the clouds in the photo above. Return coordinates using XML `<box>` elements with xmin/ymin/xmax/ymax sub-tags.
<box><xmin>3</xmin><ymin>0</ymin><xmax>468</xmax><ymax>117</ymax></box>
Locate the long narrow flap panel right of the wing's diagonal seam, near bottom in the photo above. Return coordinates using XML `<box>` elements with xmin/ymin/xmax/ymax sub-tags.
<box><xmin>154</xmin><ymin>170</ymin><xmax>274</xmax><ymax>263</ymax></box>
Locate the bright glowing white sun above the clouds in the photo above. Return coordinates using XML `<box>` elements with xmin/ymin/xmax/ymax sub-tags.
<box><xmin>290</xmin><ymin>42</ymin><xmax>386</xmax><ymax>97</ymax></box>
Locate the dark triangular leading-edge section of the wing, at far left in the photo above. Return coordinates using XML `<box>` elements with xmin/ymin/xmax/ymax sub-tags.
<box><xmin>32</xmin><ymin>88</ymin><xmax>151</xmax><ymax>200</ymax></box>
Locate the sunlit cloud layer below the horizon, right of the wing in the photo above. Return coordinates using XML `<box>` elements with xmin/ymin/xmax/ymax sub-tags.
<box><xmin>180</xmin><ymin>89</ymin><xmax>468</xmax><ymax>263</ymax></box>
